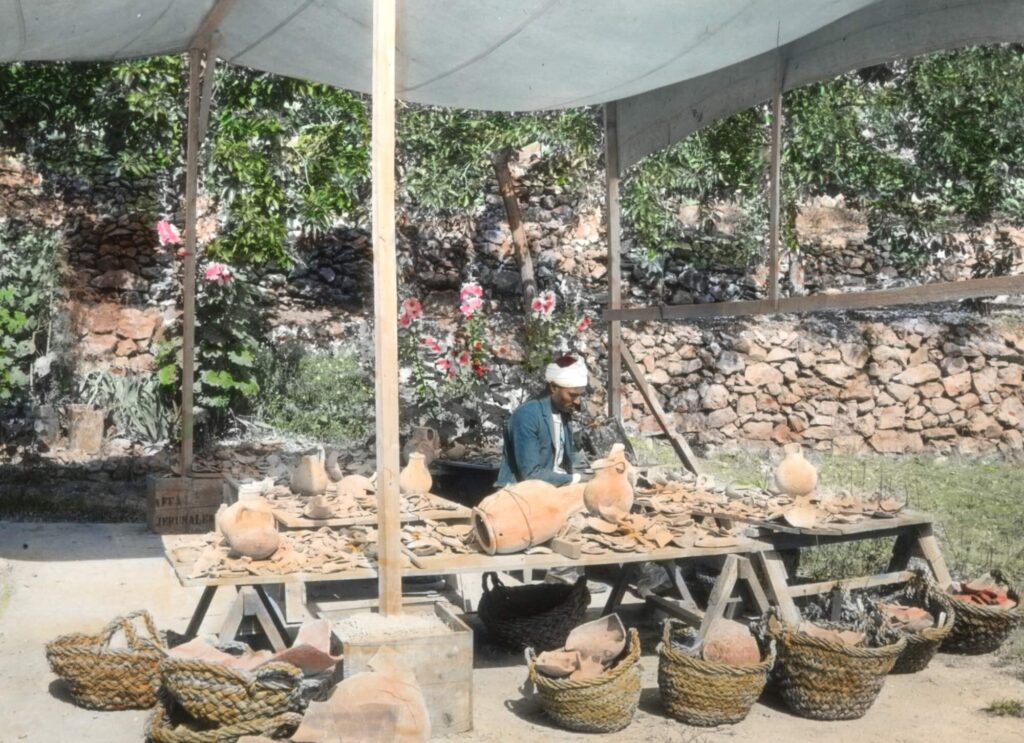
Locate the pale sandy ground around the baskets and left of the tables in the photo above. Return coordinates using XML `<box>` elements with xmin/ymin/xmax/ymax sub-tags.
<box><xmin>0</xmin><ymin>523</ymin><xmax>1024</xmax><ymax>743</ymax></box>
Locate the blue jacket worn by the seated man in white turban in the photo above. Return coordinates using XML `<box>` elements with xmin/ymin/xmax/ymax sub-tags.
<box><xmin>496</xmin><ymin>395</ymin><xmax>573</xmax><ymax>487</ymax></box>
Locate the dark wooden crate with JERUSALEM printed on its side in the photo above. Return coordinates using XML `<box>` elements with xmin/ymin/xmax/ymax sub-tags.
<box><xmin>145</xmin><ymin>475</ymin><xmax>223</xmax><ymax>534</ymax></box>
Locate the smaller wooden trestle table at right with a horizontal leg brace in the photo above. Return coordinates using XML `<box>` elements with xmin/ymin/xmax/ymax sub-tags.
<box><xmin>694</xmin><ymin>510</ymin><xmax>952</xmax><ymax>622</ymax></box>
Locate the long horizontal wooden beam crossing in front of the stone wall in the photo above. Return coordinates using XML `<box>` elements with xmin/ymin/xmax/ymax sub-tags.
<box><xmin>604</xmin><ymin>276</ymin><xmax>1024</xmax><ymax>322</ymax></box>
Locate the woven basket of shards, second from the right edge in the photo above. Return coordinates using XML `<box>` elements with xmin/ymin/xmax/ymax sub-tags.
<box><xmin>876</xmin><ymin>575</ymin><xmax>956</xmax><ymax>673</ymax></box>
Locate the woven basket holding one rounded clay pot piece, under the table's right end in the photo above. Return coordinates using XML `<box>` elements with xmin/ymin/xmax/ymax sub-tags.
<box><xmin>657</xmin><ymin>619</ymin><xmax>775</xmax><ymax>727</ymax></box>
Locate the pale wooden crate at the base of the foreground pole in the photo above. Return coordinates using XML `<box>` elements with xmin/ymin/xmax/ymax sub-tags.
<box><xmin>343</xmin><ymin>602</ymin><xmax>473</xmax><ymax>737</ymax></box>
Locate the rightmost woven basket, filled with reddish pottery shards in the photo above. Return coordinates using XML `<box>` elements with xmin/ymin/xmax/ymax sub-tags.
<box><xmin>942</xmin><ymin>570</ymin><xmax>1024</xmax><ymax>655</ymax></box>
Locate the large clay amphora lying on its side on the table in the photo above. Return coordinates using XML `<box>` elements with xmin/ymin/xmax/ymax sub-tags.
<box><xmin>473</xmin><ymin>480</ymin><xmax>579</xmax><ymax>555</ymax></box>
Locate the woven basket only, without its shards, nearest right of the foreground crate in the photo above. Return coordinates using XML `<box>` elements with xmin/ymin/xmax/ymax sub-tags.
<box><xmin>526</xmin><ymin>628</ymin><xmax>640</xmax><ymax>733</ymax></box>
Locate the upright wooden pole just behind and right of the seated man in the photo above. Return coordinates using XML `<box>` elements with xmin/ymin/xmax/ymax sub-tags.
<box><xmin>604</xmin><ymin>101</ymin><xmax>623</xmax><ymax>422</ymax></box>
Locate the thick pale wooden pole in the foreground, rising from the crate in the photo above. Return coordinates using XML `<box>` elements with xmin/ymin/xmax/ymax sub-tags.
<box><xmin>372</xmin><ymin>0</ymin><xmax>401</xmax><ymax>616</ymax></box>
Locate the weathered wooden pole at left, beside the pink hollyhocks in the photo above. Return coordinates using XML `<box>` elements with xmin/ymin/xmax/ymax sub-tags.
<box><xmin>181</xmin><ymin>47</ymin><xmax>203</xmax><ymax>477</ymax></box>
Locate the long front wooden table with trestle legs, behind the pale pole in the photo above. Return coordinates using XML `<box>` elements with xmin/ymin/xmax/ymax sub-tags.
<box><xmin>164</xmin><ymin>537</ymin><xmax>772</xmax><ymax>648</ymax></box>
